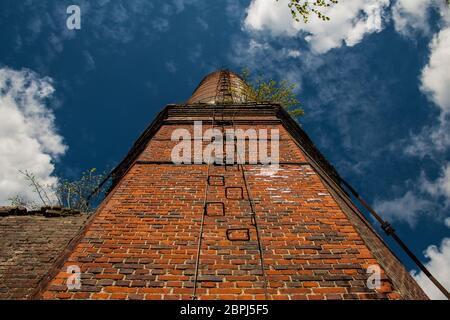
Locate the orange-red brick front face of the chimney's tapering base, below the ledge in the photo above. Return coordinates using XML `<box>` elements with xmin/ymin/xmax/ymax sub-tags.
<box><xmin>43</xmin><ymin>108</ymin><xmax>424</xmax><ymax>300</ymax></box>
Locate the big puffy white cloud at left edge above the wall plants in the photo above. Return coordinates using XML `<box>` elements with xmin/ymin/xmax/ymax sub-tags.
<box><xmin>0</xmin><ymin>68</ymin><xmax>66</xmax><ymax>204</ymax></box>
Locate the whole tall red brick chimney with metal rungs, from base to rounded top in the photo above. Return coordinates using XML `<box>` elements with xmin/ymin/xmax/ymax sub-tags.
<box><xmin>39</xmin><ymin>70</ymin><xmax>427</xmax><ymax>300</ymax></box>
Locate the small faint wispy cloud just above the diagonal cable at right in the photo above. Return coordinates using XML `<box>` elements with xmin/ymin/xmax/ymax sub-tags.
<box><xmin>374</xmin><ymin>191</ymin><xmax>431</xmax><ymax>227</ymax></box>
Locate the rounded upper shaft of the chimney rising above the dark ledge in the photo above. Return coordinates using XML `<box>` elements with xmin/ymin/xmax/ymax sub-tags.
<box><xmin>187</xmin><ymin>70</ymin><xmax>252</xmax><ymax>104</ymax></box>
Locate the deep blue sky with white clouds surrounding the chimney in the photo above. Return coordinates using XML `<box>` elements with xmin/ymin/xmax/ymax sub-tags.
<box><xmin>0</xmin><ymin>0</ymin><xmax>450</xmax><ymax>298</ymax></box>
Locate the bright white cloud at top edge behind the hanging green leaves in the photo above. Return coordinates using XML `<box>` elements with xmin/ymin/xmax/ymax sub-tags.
<box><xmin>244</xmin><ymin>0</ymin><xmax>389</xmax><ymax>53</ymax></box>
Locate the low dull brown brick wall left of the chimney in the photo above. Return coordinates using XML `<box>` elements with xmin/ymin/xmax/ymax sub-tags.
<box><xmin>0</xmin><ymin>215</ymin><xmax>87</xmax><ymax>299</ymax></box>
